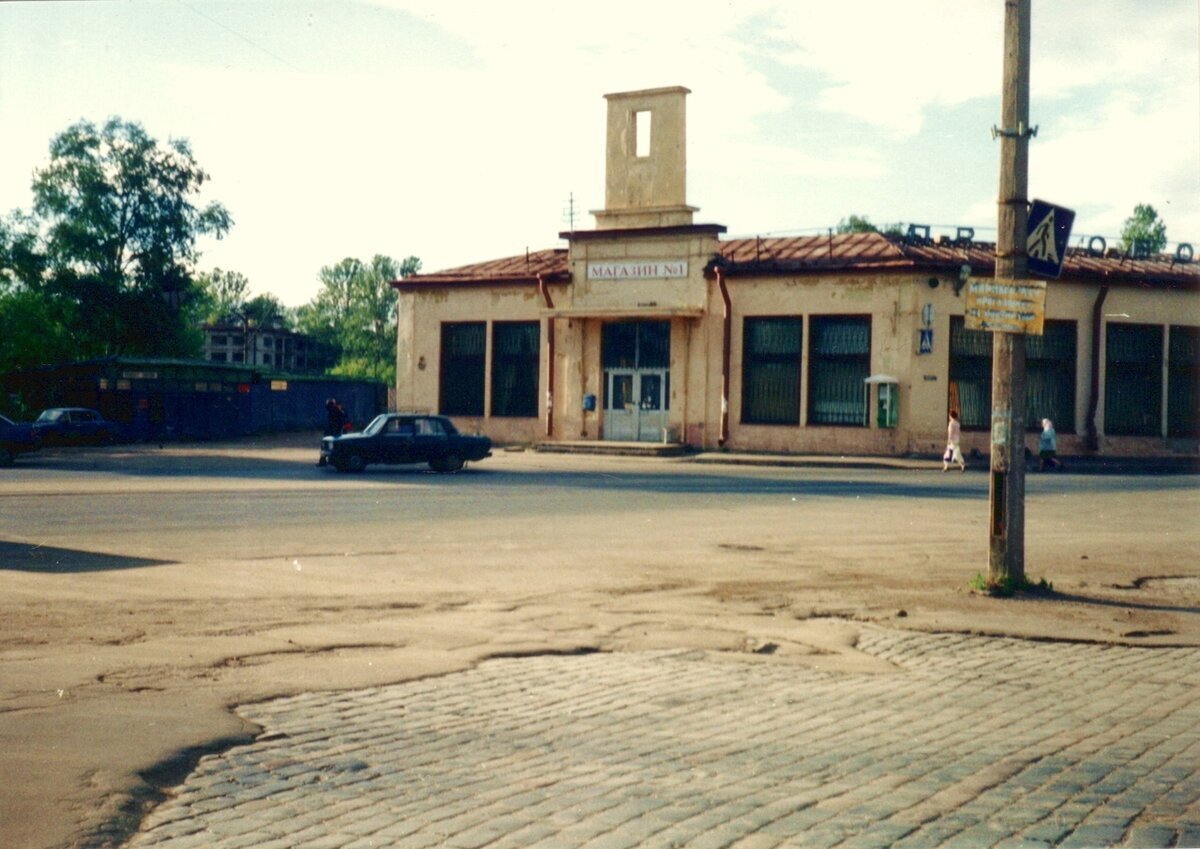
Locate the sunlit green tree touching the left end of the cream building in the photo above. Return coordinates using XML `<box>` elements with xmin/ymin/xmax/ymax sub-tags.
<box><xmin>296</xmin><ymin>254</ymin><xmax>421</xmax><ymax>384</ymax></box>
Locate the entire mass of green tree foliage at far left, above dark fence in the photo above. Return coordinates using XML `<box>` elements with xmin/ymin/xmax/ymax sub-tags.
<box><xmin>0</xmin><ymin>118</ymin><xmax>232</xmax><ymax>371</ymax></box>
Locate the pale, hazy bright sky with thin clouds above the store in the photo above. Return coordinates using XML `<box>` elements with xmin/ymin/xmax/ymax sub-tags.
<box><xmin>0</xmin><ymin>0</ymin><xmax>1200</xmax><ymax>306</ymax></box>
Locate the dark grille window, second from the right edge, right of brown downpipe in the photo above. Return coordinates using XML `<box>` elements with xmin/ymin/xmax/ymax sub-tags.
<box><xmin>1104</xmin><ymin>324</ymin><xmax>1163</xmax><ymax>436</ymax></box>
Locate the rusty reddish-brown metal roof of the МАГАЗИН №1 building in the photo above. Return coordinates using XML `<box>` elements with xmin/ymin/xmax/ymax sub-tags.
<box><xmin>394</xmin><ymin>233</ymin><xmax>1200</xmax><ymax>289</ymax></box>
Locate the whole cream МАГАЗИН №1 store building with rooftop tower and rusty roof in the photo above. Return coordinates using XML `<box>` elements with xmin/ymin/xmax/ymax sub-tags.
<box><xmin>394</xmin><ymin>88</ymin><xmax>1200</xmax><ymax>456</ymax></box>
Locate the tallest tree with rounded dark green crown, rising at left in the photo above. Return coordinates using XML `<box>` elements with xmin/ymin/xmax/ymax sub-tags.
<box><xmin>32</xmin><ymin>118</ymin><xmax>232</xmax><ymax>356</ymax></box>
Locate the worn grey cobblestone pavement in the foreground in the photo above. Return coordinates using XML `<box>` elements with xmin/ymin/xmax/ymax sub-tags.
<box><xmin>130</xmin><ymin>626</ymin><xmax>1200</xmax><ymax>849</ymax></box>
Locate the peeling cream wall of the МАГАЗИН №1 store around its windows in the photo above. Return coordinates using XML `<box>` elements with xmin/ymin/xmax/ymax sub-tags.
<box><xmin>396</xmin><ymin>272</ymin><xmax>1200</xmax><ymax>454</ymax></box>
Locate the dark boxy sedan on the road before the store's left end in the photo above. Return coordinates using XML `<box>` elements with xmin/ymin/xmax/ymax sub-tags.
<box><xmin>320</xmin><ymin>413</ymin><xmax>492</xmax><ymax>471</ymax></box>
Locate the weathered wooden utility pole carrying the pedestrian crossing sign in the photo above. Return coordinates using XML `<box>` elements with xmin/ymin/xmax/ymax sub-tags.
<box><xmin>988</xmin><ymin>0</ymin><xmax>1032</xmax><ymax>584</ymax></box>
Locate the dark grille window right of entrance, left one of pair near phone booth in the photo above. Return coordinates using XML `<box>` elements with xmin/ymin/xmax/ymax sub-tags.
<box><xmin>742</xmin><ymin>317</ymin><xmax>804</xmax><ymax>425</ymax></box>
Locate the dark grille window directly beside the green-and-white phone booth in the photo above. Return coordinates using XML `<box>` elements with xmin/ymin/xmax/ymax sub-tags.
<box><xmin>809</xmin><ymin>315</ymin><xmax>871</xmax><ymax>427</ymax></box>
